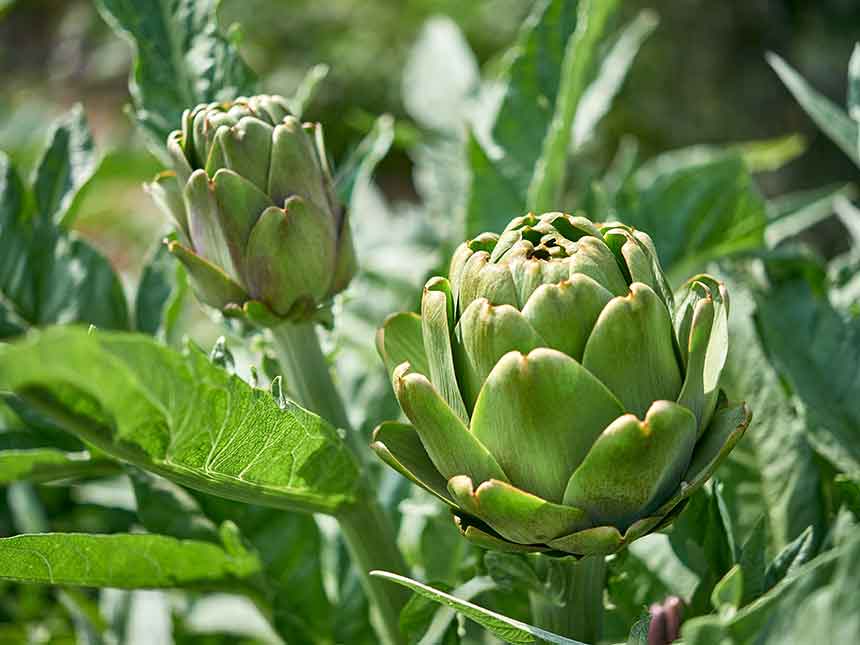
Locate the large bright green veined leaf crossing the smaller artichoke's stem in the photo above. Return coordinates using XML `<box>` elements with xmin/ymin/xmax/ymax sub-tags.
<box><xmin>0</xmin><ymin>328</ymin><xmax>358</xmax><ymax>512</ymax></box>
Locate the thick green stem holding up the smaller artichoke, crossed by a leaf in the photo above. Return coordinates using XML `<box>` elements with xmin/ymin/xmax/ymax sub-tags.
<box><xmin>272</xmin><ymin>323</ymin><xmax>408</xmax><ymax>645</ymax></box>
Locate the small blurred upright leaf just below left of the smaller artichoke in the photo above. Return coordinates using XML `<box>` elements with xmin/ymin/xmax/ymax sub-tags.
<box><xmin>134</xmin><ymin>242</ymin><xmax>189</xmax><ymax>345</ymax></box>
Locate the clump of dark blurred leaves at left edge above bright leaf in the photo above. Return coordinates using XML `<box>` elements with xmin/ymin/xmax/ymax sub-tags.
<box><xmin>0</xmin><ymin>107</ymin><xmax>129</xmax><ymax>338</ymax></box>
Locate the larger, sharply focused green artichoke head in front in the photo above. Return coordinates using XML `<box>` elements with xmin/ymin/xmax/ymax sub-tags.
<box><xmin>372</xmin><ymin>213</ymin><xmax>751</xmax><ymax>556</ymax></box>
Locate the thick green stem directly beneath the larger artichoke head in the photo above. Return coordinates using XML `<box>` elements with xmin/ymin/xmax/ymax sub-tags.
<box><xmin>529</xmin><ymin>556</ymin><xmax>606</xmax><ymax>645</ymax></box>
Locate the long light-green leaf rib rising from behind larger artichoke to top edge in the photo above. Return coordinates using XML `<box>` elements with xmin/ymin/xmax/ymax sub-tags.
<box><xmin>528</xmin><ymin>0</ymin><xmax>619</xmax><ymax>213</ymax></box>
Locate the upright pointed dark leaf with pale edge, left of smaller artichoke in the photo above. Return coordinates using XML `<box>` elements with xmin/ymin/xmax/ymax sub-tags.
<box><xmin>33</xmin><ymin>104</ymin><xmax>100</xmax><ymax>228</ymax></box>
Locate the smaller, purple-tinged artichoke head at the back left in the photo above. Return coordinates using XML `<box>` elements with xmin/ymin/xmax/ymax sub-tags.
<box><xmin>149</xmin><ymin>96</ymin><xmax>355</xmax><ymax>324</ymax></box>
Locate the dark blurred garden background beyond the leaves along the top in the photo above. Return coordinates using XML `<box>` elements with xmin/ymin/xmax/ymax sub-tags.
<box><xmin>0</xmin><ymin>0</ymin><xmax>860</xmax><ymax>286</ymax></box>
